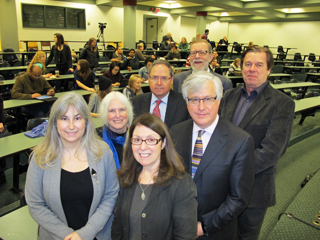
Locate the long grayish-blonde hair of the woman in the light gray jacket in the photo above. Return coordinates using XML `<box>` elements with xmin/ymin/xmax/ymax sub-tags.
<box><xmin>31</xmin><ymin>92</ymin><xmax>108</xmax><ymax>169</ymax></box>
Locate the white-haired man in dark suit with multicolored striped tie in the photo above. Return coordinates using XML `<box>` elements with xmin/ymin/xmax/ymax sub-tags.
<box><xmin>171</xmin><ymin>71</ymin><xmax>254</xmax><ymax>240</ymax></box>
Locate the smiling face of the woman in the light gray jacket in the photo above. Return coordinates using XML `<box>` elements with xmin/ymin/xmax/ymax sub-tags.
<box><xmin>57</xmin><ymin>106</ymin><xmax>86</xmax><ymax>146</ymax></box>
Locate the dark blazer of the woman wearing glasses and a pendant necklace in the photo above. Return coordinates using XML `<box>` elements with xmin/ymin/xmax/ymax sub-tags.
<box><xmin>111</xmin><ymin>174</ymin><xmax>198</xmax><ymax>240</ymax></box>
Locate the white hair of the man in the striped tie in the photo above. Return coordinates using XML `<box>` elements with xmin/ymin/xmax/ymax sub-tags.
<box><xmin>182</xmin><ymin>71</ymin><xmax>223</xmax><ymax>102</ymax></box>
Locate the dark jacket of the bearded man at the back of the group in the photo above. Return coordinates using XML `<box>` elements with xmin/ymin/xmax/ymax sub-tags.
<box><xmin>173</xmin><ymin>68</ymin><xmax>233</xmax><ymax>92</ymax></box>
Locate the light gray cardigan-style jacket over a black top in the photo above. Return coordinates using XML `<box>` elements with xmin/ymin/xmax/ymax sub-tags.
<box><xmin>25</xmin><ymin>149</ymin><xmax>119</xmax><ymax>240</ymax></box>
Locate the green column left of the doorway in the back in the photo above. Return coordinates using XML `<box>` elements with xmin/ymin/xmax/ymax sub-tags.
<box><xmin>123</xmin><ymin>0</ymin><xmax>136</xmax><ymax>49</ymax></box>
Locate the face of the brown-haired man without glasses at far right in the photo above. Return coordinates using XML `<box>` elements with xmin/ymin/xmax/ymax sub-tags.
<box><xmin>242</xmin><ymin>52</ymin><xmax>270</xmax><ymax>93</ymax></box>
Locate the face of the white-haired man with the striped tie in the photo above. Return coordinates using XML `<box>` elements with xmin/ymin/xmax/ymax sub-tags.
<box><xmin>187</xmin><ymin>82</ymin><xmax>220</xmax><ymax>129</ymax></box>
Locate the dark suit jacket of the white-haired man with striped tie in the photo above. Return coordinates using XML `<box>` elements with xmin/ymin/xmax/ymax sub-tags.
<box><xmin>171</xmin><ymin>118</ymin><xmax>254</xmax><ymax>240</ymax></box>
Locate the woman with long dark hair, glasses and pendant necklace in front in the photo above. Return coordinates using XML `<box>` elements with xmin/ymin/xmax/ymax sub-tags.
<box><xmin>111</xmin><ymin>113</ymin><xmax>198</xmax><ymax>240</ymax></box>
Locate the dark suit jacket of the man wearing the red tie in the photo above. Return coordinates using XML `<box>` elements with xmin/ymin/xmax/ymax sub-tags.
<box><xmin>131</xmin><ymin>90</ymin><xmax>190</xmax><ymax>129</ymax></box>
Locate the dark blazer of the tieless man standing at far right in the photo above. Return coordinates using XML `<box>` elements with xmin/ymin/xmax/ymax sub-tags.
<box><xmin>219</xmin><ymin>83</ymin><xmax>294</xmax><ymax>208</ymax></box>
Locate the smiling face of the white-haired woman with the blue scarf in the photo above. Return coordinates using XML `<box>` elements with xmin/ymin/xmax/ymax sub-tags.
<box><xmin>108</xmin><ymin>98</ymin><xmax>129</xmax><ymax>134</ymax></box>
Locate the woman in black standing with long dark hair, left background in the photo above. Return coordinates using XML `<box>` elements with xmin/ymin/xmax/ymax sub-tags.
<box><xmin>45</xmin><ymin>33</ymin><xmax>73</xmax><ymax>92</ymax></box>
